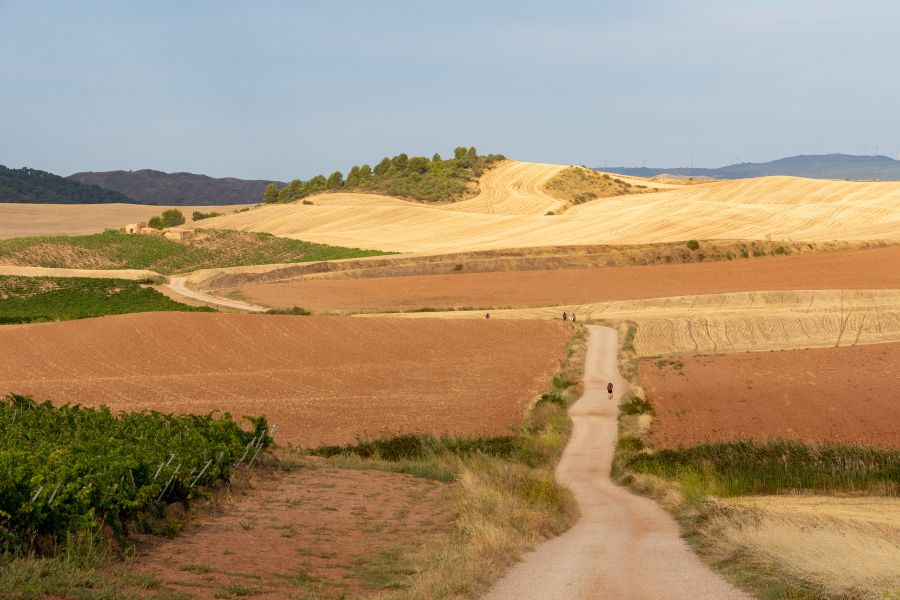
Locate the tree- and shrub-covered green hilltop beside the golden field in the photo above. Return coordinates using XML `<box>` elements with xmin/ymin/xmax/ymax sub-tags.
<box><xmin>263</xmin><ymin>146</ymin><xmax>504</xmax><ymax>203</ymax></box>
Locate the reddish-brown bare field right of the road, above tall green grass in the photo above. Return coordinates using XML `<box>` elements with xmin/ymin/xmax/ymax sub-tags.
<box><xmin>639</xmin><ymin>343</ymin><xmax>900</xmax><ymax>448</ymax></box>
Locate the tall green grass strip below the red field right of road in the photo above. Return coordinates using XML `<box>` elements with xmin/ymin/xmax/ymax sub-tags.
<box><xmin>627</xmin><ymin>441</ymin><xmax>900</xmax><ymax>500</ymax></box>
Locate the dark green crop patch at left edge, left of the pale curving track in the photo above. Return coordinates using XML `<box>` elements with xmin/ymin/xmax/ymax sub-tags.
<box><xmin>0</xmin><ymin>275</ymin><xmax>215</xmax><ymax>324</ymax></box>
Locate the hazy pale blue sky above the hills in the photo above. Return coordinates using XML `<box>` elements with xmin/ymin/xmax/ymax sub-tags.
<box><xmin>0</xmin><ymin>0</ymin><xmax>900</xmax><ymax>180</ymax></box>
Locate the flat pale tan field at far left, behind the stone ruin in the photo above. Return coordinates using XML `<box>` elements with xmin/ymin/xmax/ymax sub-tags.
<box><xmin>0</xmin><ymin>203</ymin><xmax>252</xmax><ymax>239</ymax></box>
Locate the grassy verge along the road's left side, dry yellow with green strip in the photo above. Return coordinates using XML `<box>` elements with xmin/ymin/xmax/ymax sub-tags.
<box><xmin>313</xmin><ymin>328</ymin><xmax>585</xmax><ymax>600</ymax></box>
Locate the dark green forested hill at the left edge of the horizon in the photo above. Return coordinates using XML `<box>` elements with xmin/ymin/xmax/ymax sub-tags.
<box><xmin>0</xmin><ymin>165</ymin><xmax>134</xmax><ymax>204</ymax></box>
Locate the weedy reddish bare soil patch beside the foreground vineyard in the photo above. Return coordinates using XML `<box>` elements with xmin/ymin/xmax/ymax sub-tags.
<box><xmin>132</xmin><ymin>466</ymin><xmax>451</xmax><ymax>599</ymax></box>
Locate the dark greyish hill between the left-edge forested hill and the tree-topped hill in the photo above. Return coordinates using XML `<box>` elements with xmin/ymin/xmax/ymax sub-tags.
<box><xmin>69</xmin><ymin>169</ymin><xmax>284</xmax><ymax>205</ymax></box>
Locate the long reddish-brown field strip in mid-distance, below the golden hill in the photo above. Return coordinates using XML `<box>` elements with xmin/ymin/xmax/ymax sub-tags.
<box><xmin>227</xmin><ymin>246</ymin><xmax>900</xmax><ymax>311</ymax></box>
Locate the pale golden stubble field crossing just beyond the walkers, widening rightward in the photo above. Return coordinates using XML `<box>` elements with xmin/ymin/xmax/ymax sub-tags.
<box><xmin>384</xmin><ymin>290</ymin><xmax>900</xmax><ymax>356</ymax></box>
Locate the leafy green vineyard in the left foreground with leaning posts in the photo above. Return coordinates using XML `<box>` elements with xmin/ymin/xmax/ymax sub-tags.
<box><xmin>0</xmin><ymin>394</ymin><xmax>272</xmax><ymax>552</ymax></box>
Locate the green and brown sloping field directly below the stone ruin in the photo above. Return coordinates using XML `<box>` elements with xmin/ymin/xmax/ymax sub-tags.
<box><xmin>0</xmin><ymin>230</ymin><xmax>389</xmax><ymax>274</ymax></box>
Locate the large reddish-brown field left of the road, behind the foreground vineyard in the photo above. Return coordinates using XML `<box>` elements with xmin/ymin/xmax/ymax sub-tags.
<box><xmin>0</xmin><ymin>313</ymin><xmax>570</xmax><ymax>446</ymax></box>
